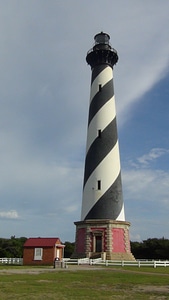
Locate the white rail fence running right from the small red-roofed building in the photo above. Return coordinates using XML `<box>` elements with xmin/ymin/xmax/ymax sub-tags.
<box><xmin>63</xmin><ymin>258</ymin><xmax>169</xmax><ymax>268</ymax></box>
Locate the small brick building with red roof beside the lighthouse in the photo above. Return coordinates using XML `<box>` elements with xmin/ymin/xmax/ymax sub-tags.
<box><xmin>23</xmin><ymin>237</ymin><xmax>65</xmax><ymax>265</ymax></box>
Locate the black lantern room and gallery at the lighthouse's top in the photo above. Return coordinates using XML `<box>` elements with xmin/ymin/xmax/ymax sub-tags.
<box><xmin>86</xmin><ymin>32</ymin><xmax>118</xmax><ymax>69</ymax></box>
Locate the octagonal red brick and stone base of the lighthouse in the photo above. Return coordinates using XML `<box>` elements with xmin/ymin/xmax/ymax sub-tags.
<box><xmin>72</xmin><ymin>219</ymin><xmax>135</xmax><ymax>260</ymax></box>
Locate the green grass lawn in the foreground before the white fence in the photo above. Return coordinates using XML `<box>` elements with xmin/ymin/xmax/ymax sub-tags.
<box><xmin>0</xmin><ymin>266</ymin><xmax>169</xmax><ymax>300</ymax></box>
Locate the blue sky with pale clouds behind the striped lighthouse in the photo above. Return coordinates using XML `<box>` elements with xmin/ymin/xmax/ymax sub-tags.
<box><xmin>0</xmin><ymin>0</ymin><xmax>169</xmax><ymax>242</ymax></box>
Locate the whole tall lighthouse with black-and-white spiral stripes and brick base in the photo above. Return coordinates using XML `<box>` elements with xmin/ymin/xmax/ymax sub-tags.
<box><xmin>73</xmin><ymin>32</ymin><xmax>134</xmax><ymax>260</ymax></box>
